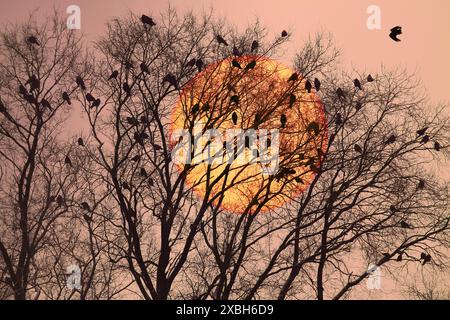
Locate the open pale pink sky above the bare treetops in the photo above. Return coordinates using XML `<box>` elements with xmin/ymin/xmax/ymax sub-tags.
<box><xmin>0</xmin><ymin>0</ymin><xmax>450</xmax><ymax>102</ymax></box>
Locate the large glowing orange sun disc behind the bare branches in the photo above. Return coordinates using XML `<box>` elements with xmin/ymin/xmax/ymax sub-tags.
<box><xmin>169</xmin><ymin>55</ymin><xmax>327</xmax><ymax>213</ymax></box>
